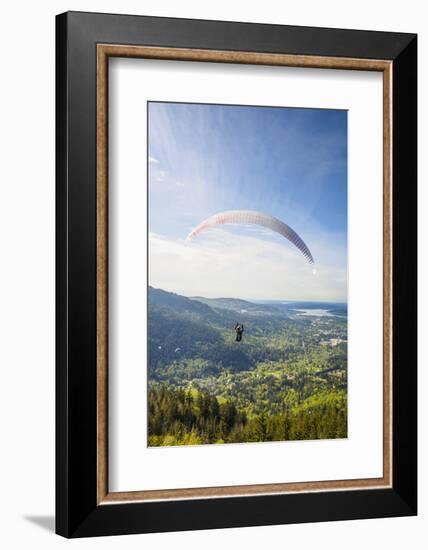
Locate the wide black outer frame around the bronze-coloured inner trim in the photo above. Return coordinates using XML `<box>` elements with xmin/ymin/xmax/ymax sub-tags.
<box><xmin>56</xmin><ymin>12</ymin><xmax>417</xmax><ymax>537</ymax></box>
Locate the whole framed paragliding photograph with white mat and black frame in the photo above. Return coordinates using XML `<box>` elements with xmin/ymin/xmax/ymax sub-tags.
<box><xmin>56</xmin><ymin>12</ymin><xmax>417</xmax><ymax>537</ymax></box>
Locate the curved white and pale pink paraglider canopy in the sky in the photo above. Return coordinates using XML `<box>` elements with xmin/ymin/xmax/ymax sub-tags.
<box><xmin>186</xmin><ymin>210</ymin><xmax>314</xmax><ymax>264</ymax></box>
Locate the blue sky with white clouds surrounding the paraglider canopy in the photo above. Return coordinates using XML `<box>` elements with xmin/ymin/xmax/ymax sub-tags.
<box><xmin>148</xmin><ymin>102</ymin><xmax>347</xmax><ymax>302</ymax></box>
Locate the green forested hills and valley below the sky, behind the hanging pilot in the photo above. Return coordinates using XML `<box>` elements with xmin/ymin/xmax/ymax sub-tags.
<box><xmin>148</xmin><ymin>288</ymin><xmax>347</xmax><ymax>446</ymax></box>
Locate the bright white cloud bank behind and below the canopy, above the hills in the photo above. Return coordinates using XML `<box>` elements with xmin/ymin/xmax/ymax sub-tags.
<box><xmin>149</xmin><ymin>229</ymin><xmax>347</xmax><ymax>301</ymax></box>
